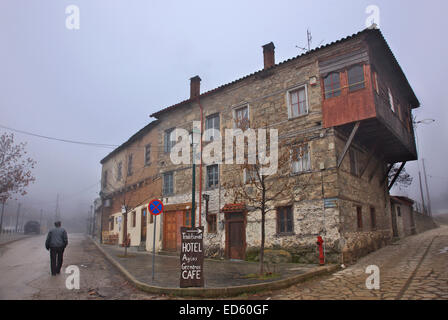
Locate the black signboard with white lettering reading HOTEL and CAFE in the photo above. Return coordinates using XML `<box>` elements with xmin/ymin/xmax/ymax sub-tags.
<box><xmin>180</xmin><ymin>227</ymin><xmax>204</xmax><ymax>288</ymax></box>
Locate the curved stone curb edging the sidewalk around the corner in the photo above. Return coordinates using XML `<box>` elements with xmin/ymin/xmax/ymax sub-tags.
<box><xmin>88</xmin><ymin>237</ymin><xmax>340</xmax><ymax>298</ymax></box>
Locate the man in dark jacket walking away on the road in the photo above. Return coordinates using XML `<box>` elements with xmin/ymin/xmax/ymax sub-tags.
<box><xmin>45</xmin><ymin>221</ymin><xmax>68</xmax><ymax>276</ymax></box>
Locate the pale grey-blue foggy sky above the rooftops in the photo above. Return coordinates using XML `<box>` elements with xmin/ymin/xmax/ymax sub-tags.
<box><xmin>0</xmin><ymin>0</ymin><xmax>448</xmax><ymax>228</ymax></box>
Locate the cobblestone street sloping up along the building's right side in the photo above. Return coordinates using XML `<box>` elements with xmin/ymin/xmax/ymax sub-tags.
<box><xmin>248</xmin><ymin>226</ymin><xmax>448</xmax><ymax>300</ymax></box>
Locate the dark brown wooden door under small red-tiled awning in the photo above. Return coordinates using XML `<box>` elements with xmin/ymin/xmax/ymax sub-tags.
<box><xmin>226</xmin><ymin>212</ymin><xmax>246</xmax><ymax>260</ymax></box>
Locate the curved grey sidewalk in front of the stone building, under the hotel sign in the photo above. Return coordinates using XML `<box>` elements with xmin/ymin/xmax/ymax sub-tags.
<box><xmin>93</xmin><ymin>240</ymin><xmax>337</xmax><ymax>297</ymax></box>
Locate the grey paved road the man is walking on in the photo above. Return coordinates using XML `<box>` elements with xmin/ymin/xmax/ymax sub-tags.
<box><xmin>0</xmin><ymin>234</ymin><xmax>163</xmax><ymax>299</ymax></box>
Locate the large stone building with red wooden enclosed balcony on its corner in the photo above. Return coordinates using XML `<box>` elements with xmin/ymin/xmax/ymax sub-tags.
<box><xmin>98</xmin><ymin>29</ymin><xmax>420</xmax><ymax>263</ymax></box>
